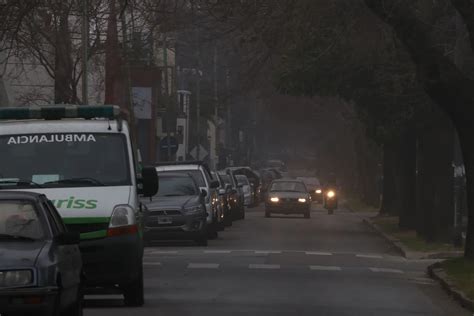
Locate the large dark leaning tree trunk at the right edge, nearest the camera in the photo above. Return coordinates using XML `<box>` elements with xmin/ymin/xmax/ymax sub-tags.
<box><xmin>365</xmin><ymin>0</ymin><xmax>474</xmax><ymax>259</ymax></box>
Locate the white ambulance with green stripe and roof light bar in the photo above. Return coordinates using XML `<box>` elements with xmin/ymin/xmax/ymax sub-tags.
<box><xmin>0</xmin><ymin>105</ymin><xmax>158</xmax><ymax>306</ymax></box>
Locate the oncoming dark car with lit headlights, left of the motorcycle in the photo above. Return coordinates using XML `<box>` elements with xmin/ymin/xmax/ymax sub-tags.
<box><xmin>265</xmin><ymin>180</ymin><xmax>311</xmax><ymax>218</ymax></box>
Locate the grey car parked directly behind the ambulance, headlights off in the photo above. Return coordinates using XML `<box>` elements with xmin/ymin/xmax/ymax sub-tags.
<box><xmin>143</xmin><ymin>171</ymin><xmax>208</xmax><ymax>246</ymax></box>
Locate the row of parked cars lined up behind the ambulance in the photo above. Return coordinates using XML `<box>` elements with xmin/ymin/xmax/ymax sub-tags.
<box><xmin>142</xmin><ymin>161</ymin><xmax>261</xmax><ymax>246</ymax></box>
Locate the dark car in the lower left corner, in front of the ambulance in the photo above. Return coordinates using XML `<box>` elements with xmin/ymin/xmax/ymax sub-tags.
<box><xmin>0</xmin><ymin>191</ymin><xmax>83</xmax><ymax>316</ymax></box>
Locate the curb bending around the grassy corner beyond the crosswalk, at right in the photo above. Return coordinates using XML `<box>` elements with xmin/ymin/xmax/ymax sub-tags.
<box><xmin>363</xmin><ymin>218</ymin><xmax>463</xmax><ymax>259</ymax></box>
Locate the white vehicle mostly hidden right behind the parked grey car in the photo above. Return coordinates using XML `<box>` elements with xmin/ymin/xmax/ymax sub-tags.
<box><xmin>156</xmin><ymin>161</ymin><xmax>223</xmax><ymax>238</ymax></box>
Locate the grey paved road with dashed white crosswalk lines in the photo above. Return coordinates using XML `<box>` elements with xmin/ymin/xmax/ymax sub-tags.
<box><xmin>85</xmin><ymin>207</ymin><xmax>470</xmax><ymax>316</ymax></box>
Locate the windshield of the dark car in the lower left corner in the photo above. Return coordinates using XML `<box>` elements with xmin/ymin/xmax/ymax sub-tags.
<box><xmin>0</xmin><ymin>201</ymin><xmax>44</xmax><ymax>242</ymax></box>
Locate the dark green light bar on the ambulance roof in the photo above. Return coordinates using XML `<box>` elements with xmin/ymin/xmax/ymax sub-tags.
<box><xmin>0</xmin><ymin>105</ymin><xmax>120</xmax><ymax>120</ymax></box>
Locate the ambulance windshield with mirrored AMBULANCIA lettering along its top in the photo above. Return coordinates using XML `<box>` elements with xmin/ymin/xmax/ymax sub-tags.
<box><xmin>0</xmin><ymin>133</ymin><xmax>131</xmax><ymax>189</ymax></box>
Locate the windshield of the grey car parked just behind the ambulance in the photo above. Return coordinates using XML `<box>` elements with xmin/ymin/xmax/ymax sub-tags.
<box><xmin>157</xmin><ymin>173</ymin><xmax>198</xmax><ymax>196</ymax></box>
